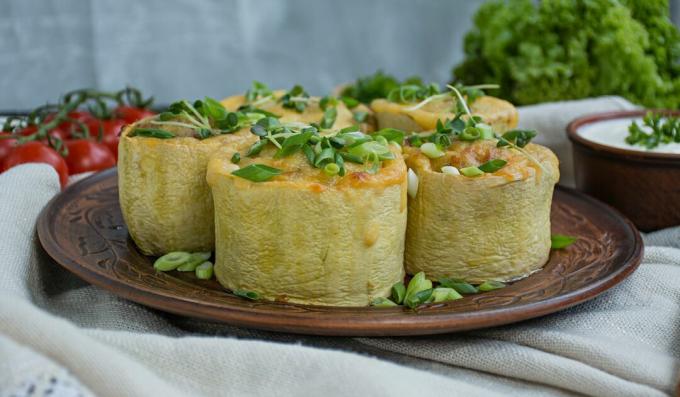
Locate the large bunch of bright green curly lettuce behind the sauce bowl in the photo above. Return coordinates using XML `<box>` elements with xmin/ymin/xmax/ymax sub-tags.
<box><xmin>453</xmin><ymin>0</ymin><xmax>680</xmax><ymax>108</ymax></box>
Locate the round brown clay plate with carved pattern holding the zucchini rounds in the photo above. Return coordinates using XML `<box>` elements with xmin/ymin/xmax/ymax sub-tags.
<box><xmin>38</xmin><ymin>169</ymin><xmax>642</xmax><ymax>336</ymax></box>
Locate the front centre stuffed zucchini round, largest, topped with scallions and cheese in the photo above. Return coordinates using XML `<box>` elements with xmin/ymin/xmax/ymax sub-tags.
<box><xmin>207</xmin><ymin>119</ymin><xmax>407</xmax><ymax>306</ymax></box>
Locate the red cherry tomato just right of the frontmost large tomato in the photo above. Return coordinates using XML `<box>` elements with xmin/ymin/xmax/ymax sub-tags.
<box><xmin>66</xmin><ymin>139</ymin><xmax>116</xmax><ymax>175</ymax></box>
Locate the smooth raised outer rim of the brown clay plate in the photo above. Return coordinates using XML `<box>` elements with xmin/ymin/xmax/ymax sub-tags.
<box><xmin>37</xmin><ymin>168</ymin><xmax>643</xmax><ymax>336</ymax></box>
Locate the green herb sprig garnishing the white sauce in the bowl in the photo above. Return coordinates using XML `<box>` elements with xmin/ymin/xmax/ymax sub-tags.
<box><xmin>626</xmin><ymin>112</ymin><xmax>680</xmax><ymax>149</ymax></box>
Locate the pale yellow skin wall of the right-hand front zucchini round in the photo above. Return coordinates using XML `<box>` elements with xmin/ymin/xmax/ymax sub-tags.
<box><xmin>404</xmin><ymin>144</ymin><xmax>559</xmax><ymax>283</ymax></box>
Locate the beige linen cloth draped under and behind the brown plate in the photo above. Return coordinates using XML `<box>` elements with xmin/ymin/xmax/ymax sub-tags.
<box><xmin>0</xmin><ymin>97</ymin><xmax>680</xmax><ymax>396</ymax></box>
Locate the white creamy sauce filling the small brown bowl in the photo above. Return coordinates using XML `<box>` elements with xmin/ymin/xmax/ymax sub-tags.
<box><xmin>576</xmin><ymin>117</ymin><xmax>680</xmax><ymax>154</ymax></box>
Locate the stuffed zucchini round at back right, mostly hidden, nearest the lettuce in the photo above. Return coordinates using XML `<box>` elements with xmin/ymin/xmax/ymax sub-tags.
<box><xmin>371</xmin><ymin>85</ymin><xmax>518</xmax><ymax>132</ymax></box>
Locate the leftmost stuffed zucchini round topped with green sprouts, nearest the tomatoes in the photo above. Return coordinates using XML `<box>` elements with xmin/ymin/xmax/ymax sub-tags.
<box><xmin>118</xmin><ymin>100</ymin><xmax>264</xmax><ymax>255</ymax></box>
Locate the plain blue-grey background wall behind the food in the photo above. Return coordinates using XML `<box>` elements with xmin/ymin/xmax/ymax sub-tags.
<box><xmin>0</xmin><ymin>0</ymin><xmax>680</xmax><ymax>110</ymax></box>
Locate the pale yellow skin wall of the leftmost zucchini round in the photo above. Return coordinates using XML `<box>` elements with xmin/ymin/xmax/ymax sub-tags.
<box><xmin>118</xmin><ymin>125</ymin><xmax>256</xmax><ymax>256</ymax></box>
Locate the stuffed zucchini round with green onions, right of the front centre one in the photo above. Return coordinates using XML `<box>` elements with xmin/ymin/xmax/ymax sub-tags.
<box><xmin>405</xmin><ymin>120</ymin><xmax>559</xmax><ymax>283</ymax></box>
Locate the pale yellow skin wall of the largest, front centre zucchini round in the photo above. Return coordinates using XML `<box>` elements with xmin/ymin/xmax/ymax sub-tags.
<box><xmin>208</xmin><ymin>147</ymin><xmax>407</xmax><ymax>306</ymax></box>
